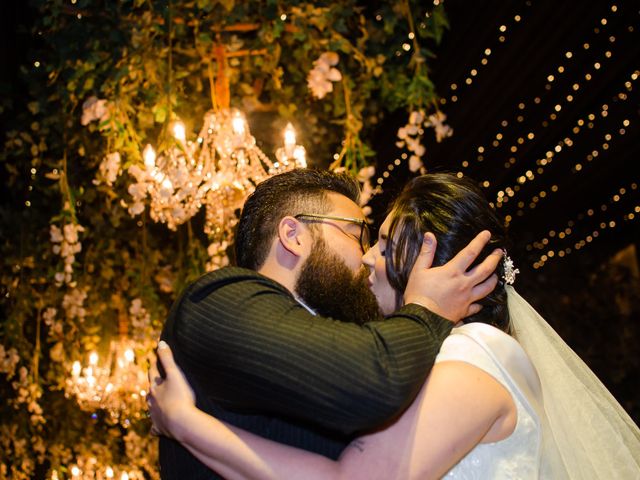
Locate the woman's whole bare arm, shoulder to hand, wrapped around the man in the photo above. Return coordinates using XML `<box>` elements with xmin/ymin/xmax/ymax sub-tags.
<box><xmin>151</xmin><ymin>342</ymin><xmax>515</xmax><ymax>480</ymax></box>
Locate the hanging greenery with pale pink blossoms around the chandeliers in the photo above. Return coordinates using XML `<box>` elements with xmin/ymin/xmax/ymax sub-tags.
<box><xmin>0</xmin><ymin>0</ymin><xmax>447</xmax><ymax>479</ymax></box>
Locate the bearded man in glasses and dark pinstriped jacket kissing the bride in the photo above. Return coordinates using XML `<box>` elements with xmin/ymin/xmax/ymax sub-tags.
<box><xmin>160</xmin><ymin>169</ymin><xmax>499</xmax><ymax>479</ymax></box>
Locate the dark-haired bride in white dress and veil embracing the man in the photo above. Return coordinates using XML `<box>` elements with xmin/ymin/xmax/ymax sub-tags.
<box><xmin>149</xmin><ymin>174</ymin><xmax>640</xmax><ymax>479</ymax></box>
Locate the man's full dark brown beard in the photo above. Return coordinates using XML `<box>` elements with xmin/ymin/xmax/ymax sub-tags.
<box><xmin>295</xmin><ymin>238</ymin><xmax>383</xmax><ymax>325</ymax></box>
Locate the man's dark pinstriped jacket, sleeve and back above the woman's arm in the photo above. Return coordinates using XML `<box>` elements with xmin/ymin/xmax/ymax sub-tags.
<box><xmin>163</xmin><ymin>268</ymin><xmax>452</xmax><ymax>434</ymax></box>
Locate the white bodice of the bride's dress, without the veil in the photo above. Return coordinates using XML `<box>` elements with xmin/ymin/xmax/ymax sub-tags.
<box><xmin>436</xmin><ymin>323</ymin><xmax>541</xmax><ymax>480</ymax></box>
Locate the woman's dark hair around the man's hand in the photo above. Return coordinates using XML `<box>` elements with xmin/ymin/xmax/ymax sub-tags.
<box><xmin>385</xmin><ymin>173</ymin><xmax>509</xmax><ymax>332</ymax></box>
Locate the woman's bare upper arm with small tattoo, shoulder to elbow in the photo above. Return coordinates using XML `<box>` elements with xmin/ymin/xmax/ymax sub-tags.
<box><xmin>340</xmin><ymin>361</ymin><xmax>516</xmax><ymax>480</ymax></box>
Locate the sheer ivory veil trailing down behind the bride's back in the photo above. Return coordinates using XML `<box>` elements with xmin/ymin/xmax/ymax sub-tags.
<box><xmin>506</xmin><ymin>285</ymin><xmax>640</xmax><ymax>480</ymax></box>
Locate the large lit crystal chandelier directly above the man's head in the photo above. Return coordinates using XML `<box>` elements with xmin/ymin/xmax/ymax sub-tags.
<box><xmin>129</xmin><ymin>45</ymin><xmax>307</xmax><ymax>240</ymax></box>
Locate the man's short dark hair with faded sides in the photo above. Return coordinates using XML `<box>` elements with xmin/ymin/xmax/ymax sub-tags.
<box><xmin>235</xmin><ymin>168</ymin><xmax>360</xmax><ymax>270</ymax></box>
